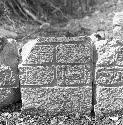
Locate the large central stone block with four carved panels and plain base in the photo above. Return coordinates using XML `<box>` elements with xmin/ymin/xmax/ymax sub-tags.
<box><xmin>20</xmin><ymin>37</ymin><xmax>92</xmax><ymax>112</ymax></box>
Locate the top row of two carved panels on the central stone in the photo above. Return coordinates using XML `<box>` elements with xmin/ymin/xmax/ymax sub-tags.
<box><xmin>22</xmin><ymin>44</ymin><xmax>91</xmax><ymax>64</ymax></box>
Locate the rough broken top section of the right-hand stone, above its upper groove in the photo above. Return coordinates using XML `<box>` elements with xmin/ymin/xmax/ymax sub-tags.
<box><xmin>95</xmin><ymin>40</ymin><xmax>123</xmax><ymax>67</ymax></box>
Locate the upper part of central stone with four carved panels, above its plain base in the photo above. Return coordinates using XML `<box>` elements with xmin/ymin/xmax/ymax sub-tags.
<box><xmin>20</xmin><ymin>37</ymin><xmax>92</xmax><ymax>86</ymax></box>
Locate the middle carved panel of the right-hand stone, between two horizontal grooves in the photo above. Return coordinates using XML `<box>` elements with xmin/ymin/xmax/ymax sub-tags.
<box><xmin>96</xmin><ymin>66</ymin><xmax>123</xmax><ymax>87</ymax></box>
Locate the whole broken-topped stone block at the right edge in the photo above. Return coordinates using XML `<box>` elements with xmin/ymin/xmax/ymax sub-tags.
<box><xmin>95</xmin><ymin>40</ymin><xmax>123</xmax><ymax>116</ymax></box>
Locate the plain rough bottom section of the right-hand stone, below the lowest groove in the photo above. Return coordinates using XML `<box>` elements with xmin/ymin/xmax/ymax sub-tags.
<box><xmin>95</xmin><ymin>86</ymin><xmax>123</xmax><ymax>116</ymax></box>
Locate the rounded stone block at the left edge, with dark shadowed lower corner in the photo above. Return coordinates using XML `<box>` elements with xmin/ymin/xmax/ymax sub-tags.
<box><xmin>0</xmin><ymin>41</ymin><xmax>21</xmax><ymax>112</ymax></box>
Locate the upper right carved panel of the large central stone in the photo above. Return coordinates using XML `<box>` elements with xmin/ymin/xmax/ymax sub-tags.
<box><xmin>56</xmin><ymin>42</ymin><xmax>91</xmax><ymax>64</ymax></box>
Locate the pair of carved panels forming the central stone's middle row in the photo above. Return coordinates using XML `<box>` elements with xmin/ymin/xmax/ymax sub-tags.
<box><xmin>20</xmin><ymin>65</ymin><xmax>91</xmax><ymax>86</ymax></box>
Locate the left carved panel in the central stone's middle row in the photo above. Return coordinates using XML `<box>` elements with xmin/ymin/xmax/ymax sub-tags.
<box><xmin>20</xmin><ymin>66</ymin><xmax>54</xmax><ymax>86</ymax></box>
